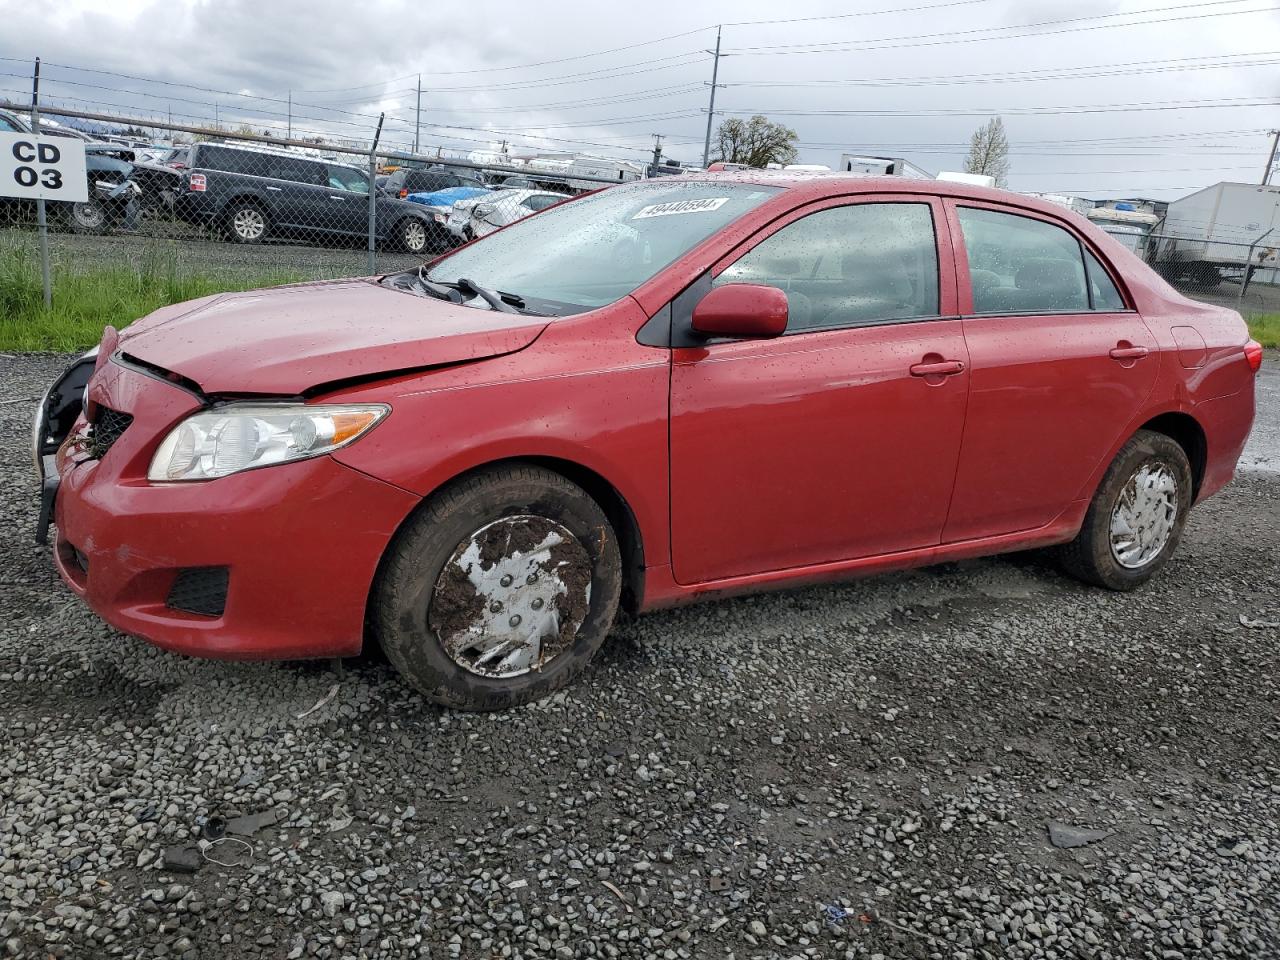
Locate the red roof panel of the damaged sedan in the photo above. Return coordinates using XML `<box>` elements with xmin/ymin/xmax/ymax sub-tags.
<box><xmin>670</xmin><ymin>170</ymin><xmax>1070</xmax><ymax>219</ymax></box>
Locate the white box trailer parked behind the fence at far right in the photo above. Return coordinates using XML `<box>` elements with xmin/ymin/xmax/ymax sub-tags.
<box><xmin>1151</xmin><ymin>183</ymin><xmax>1280</xmax><ymax>285</ymax></box>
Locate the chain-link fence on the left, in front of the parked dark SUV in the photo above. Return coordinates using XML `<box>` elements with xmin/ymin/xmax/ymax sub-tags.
<box><xmin>0</xmin><ymin>109</ymin><xmax>645</xmax><ymax>300</ymax></box>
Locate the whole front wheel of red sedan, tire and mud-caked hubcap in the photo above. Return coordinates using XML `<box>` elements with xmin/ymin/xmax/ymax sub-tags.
<box><xmin>371</xmin><ymin>466</ymin><xmax>622</xmax><ymax>710</ymax></box>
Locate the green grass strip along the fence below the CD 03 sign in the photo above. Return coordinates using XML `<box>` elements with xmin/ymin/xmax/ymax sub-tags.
<box><xmin>0</xmin><ymin>241</ymin><xmax>303</xmax><ymax>352</ymax></box>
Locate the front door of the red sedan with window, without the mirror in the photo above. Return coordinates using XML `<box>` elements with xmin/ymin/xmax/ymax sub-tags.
<box><xmin>671</xmin><ymin>195</ymin><xmax>968</xmax><ymax>584</ymax></box>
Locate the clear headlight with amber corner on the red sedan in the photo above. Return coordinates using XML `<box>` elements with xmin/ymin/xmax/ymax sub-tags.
<box><xmin>147</xmin><ymin>403</ymin><xmax>390</xmax><ymax>481</ymax></box>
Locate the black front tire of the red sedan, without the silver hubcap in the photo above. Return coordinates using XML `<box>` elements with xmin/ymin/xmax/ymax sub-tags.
<box><xmin>370</xmin><ymin>466</ymin><xmax>622</xmax><ymax>710</ymax></box>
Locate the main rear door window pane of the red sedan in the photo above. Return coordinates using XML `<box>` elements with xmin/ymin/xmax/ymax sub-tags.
<box><xmin>957</xmin><ymin>206</ymin><xmax>1090</xmax><ymax>314</ymax></box>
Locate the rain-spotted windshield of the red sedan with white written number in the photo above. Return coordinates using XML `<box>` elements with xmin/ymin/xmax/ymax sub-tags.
<box><xmin>428</xmin><ymin>180</ymin><xmax>778</xmax><ymax>315</ymax></box>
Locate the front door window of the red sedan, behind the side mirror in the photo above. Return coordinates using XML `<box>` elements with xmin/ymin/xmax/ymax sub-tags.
<box><xmin>714</xmin><ymin>204</ymin><xmax>938</xmax><ymax>332</ymax></box>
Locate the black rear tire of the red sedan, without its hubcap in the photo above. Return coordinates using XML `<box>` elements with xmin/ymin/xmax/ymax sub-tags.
<box><xmin>1059</xmin><ymin>430</ymin><xmax>1193</xmax><ymax>590</ymax></box>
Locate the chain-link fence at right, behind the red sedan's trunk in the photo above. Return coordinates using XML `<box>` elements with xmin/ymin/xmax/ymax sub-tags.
<box><xmin>1133</xmin><ymin>232</ymin><xmax>1280</xmax><ymax>314</ymax></box>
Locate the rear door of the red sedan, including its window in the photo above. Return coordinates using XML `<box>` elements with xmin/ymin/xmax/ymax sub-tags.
<box><xmin>943</xmin><ymin>201</ymin><xmax>1157</xmax><ymax>543</ymax></box>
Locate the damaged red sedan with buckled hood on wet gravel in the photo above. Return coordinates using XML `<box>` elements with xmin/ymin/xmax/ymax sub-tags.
<box><xmin>36</xmin><ymin>172</ymin><xmax>1261</xmax><ymax>709</ymax></box>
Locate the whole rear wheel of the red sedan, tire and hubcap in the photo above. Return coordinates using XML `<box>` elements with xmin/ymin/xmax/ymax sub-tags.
<box><xmin>1060</xmin><ymin>430</ymin><xmax>1192</xmax><ymax>590</ymax></box>
